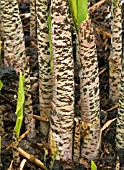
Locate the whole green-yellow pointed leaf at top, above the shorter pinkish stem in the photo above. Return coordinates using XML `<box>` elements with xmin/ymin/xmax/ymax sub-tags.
<box><xmin>68</xmin><ymin>0</ymin><xmax>88</xmax><ymax>31</ymax></box>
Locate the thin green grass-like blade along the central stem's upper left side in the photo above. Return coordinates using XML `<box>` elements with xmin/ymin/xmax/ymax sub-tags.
<box><xmin>48</xmin><ymin>7</ymin><xmax>53</xmax><ymax>73</ymax></box>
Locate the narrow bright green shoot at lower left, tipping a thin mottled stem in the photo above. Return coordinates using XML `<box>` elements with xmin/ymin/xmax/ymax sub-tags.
<box><xmin>14</xmin><ymin>71</ymin><xmax>25</xmax><ymax>136</ymax></box>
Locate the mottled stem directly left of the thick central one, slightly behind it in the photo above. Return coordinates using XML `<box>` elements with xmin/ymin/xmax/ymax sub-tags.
<box><xmin>36</xmin><ymin>0</ymin><xmax>52</xmax><ymax>139</ymax></box>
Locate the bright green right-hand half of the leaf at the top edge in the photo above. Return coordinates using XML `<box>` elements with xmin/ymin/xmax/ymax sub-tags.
<box><xmin>77</xmin><ymin>0</ymin><xmax>88</xmax><ymax>28</ymax></box>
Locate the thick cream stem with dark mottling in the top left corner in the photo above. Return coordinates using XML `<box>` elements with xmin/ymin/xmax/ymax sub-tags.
<box><xmin>1</xmin><ymin>0</ymin><xmax>26</xmax><ymax>65</ymax></box>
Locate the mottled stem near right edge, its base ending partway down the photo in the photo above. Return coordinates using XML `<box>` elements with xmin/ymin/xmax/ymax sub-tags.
<box><xmin>109</xmin><ymin>0</ymin><xmax>122</xmax><ymax>103</ymax></box>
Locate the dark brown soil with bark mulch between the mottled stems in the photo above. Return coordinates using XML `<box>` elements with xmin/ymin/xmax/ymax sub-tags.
<box><xmin>0</xmin><ymin>0</ymin><xmax>124</xmax><ymax>170</ymax></box>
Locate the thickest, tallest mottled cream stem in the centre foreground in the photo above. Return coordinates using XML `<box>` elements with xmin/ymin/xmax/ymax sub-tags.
<box><xmin>49</xmin><ymin>0</ymin><xmax>74</xmax><ymax>161</ymax></box>
